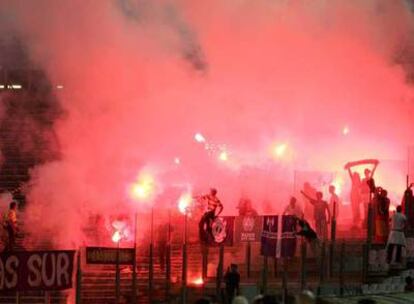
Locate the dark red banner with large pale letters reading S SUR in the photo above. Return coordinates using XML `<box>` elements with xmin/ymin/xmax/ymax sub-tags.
<box><xmin>0</xmin><ymin>251</ymin><xmax>75</xmax><ymax>291</ymax></box>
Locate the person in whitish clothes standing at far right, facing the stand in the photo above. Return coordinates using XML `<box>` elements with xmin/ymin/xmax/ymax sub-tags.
<box><xmin>387</xmin><ymin>206</ymin><xmax>407</xmax><ymax>264</ymax></box>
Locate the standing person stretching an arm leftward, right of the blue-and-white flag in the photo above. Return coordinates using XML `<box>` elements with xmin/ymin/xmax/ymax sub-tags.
<box><xmin>301</xmin><ymin>191</ymin><xmax>331</xmax><ymax>240</ymax></box>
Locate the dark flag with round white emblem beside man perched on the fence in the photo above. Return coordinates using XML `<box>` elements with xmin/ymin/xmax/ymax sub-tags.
<box><xmin>207</xmin><ymin>216</ymin><xmax>234</xmax><ymax>246</ymax></box>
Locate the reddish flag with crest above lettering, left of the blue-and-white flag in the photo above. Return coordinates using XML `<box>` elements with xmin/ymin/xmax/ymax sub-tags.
<box><xmin>235</xmin><ymin>216</ymin><xmax>263</xmax><ymax>242</ymax></box>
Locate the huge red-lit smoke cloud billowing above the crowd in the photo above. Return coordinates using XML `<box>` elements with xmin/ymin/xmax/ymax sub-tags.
<box><xmin>2</xmin><ymin>0</ymin><xmax>414</xmax><ymax>246</ymax></box>
